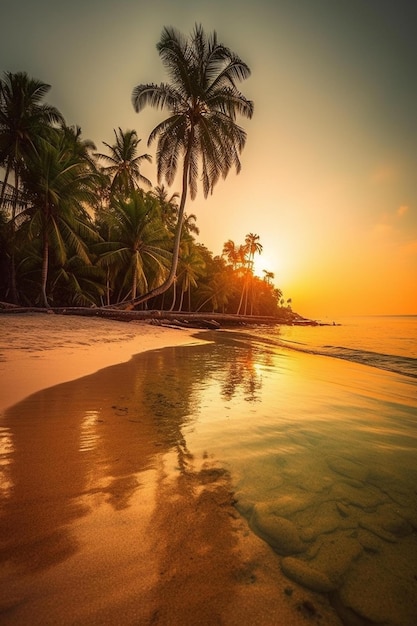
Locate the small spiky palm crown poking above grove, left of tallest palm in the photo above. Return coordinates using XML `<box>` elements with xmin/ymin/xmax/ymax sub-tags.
<box><xmin>95</xmin><ymin>127</ymin><xmax>152</xmax><ymax>196</ymax></box>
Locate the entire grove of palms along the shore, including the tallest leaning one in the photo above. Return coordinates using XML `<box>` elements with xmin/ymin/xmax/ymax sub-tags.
<box><xmin>0</xmin><ymin>25</ymin><xmax>290</xmax><ymax>315</ymax></box>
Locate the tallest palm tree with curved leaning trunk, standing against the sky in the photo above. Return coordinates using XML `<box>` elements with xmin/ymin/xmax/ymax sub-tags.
<box><xmin>132</xmin><ymin>25</ymin><xmax>253</xmax><ymax>302</ymax></box>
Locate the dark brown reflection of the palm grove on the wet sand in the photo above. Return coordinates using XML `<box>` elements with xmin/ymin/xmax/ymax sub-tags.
<box><xmin>0</xmin><ymin>333</ymin><xmax>269</xmax><ymax>571</ymax></box>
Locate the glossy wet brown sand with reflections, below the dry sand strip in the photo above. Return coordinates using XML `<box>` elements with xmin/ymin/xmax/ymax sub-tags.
<box><xmin>0</xmin><ymin>346</ymin><xmax>339</xmax><ymax>626</ymax></box>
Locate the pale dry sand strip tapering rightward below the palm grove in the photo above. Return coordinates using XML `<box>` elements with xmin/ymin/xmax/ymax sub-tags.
<box><xmin>0</xmin><ymin>312</ymin><xmax>202</xmax><ymax>414</ymax></box>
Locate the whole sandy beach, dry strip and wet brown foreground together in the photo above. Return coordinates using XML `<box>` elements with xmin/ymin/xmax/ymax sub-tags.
<box><xmin>0</xmin><ymin>316</ymin><xmax>340</xmax><ymax>626</ymax></box>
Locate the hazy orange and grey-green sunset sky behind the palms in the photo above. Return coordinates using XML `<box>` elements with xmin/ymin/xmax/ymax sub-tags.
<box><xmin>0</xmin><ymin>0</ymin><xmax>417</xmax><ymax>319</ymax></box>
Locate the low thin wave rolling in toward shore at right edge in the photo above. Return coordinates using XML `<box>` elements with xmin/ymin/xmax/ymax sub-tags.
<box><xmin>279</xmin><ymin>339</ymin><xmax>417</xmax><ymax>378</ymax></box>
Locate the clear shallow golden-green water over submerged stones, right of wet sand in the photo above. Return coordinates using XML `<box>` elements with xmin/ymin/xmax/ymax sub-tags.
<box><xmin>177</xmin><ymin>327</ymin><xmax>417</xmax><ymax>626</ymax></box>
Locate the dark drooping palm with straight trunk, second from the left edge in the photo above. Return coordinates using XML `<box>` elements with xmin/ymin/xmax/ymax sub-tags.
<box><xmin>22</xmin><ymin>129</ymin><xmax>98</xmax><ymax>307</ymax></box>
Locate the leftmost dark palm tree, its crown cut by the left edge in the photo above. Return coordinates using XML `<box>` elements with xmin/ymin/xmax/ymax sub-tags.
<box><xmin>0</xmin><ymin>72</ymin><xmax>64</xmax><ymax>302</ymax></box>
